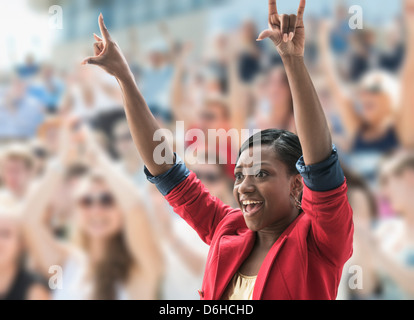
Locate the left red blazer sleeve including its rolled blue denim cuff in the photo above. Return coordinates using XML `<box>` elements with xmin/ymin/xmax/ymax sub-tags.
<box><xmin>145</xmin><ymin>156</ymin><xmax>235</xmax><ymax>245</ymax></box>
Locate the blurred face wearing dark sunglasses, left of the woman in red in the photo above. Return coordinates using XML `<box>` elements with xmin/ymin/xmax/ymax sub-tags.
<box><xmin>77</xmin><ymin>182</ymin><xmax>122</xmax><ymax>239</ymax></box>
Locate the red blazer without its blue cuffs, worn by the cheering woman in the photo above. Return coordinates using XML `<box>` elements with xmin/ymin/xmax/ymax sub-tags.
<box><xmin>166</xmin><ymin>173</ymin><xmax>353</xmax><ymax>300</ymax></box>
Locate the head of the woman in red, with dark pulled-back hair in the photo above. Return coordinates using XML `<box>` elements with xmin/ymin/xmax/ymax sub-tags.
<box><xmin>234</xmin><ymin>130</ymin><xmax>303</xmax><ymax>231</ymax></box>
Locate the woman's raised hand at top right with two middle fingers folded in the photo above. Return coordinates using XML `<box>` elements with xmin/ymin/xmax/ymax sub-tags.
<box><xmin>257</xmin><ymin>0</ymin><xmax>306</xmax><ymax>56</ymax></box>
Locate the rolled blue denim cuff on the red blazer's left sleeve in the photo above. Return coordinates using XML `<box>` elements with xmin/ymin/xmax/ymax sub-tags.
<box><xmin>144</xmin><ymin>154</ymin><xmax>190</xmax><ymax>197</ymax></box>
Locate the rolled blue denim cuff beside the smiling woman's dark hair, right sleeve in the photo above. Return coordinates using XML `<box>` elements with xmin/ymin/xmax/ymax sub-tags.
<box><xmin>296</xmin><ymin>146</ymin><xmax>345</xmax><ymax>192</ymax></box>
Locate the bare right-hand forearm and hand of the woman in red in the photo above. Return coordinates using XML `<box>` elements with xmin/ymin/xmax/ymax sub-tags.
<box><xmin>258</xmin><ymin>0</ymin><xmax>332</xmax><ymax>165</ymax></box>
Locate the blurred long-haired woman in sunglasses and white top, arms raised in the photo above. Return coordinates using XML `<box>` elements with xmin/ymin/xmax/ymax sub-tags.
<box><xmin>22</xmin><ymin>119</ymin><xmax>163</xmax><ymax>300</ymax></box>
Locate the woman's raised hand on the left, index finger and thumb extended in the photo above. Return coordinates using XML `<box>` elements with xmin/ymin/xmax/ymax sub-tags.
<box><xmin>82</xmin><ymin>13</ymin><xmax>130</xmax><ymax>79</ymax></box>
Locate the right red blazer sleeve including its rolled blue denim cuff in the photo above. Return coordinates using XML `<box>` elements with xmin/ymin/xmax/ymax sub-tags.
<box><xmin>298</xmin><ymin>147</ymin><xmax>354</xmax><ymax>268</ymax></box>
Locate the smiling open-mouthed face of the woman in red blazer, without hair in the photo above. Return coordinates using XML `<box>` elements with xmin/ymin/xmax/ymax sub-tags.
<box><xmin>234</xmin><ymin>146</ymin><xmax>302</xmax><ymax>232</ymax></box>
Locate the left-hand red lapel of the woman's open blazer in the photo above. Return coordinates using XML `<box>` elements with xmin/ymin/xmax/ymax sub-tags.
<box><xmin>213</xmin><ymin>230</ymin><xmax>256</xmax><ymax>300</ymax></box>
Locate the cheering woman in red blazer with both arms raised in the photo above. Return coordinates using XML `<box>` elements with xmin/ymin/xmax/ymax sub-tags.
<box><xmin>84</xmin><ymin>0</ymin><xmax>353</xmax><ymax>300</ymax></box>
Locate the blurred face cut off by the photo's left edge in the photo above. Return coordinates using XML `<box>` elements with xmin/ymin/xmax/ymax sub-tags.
<box><xmin>0</xmin><ymin>217</ymin><xmax>22</xmax><ymax>269</ymax></box>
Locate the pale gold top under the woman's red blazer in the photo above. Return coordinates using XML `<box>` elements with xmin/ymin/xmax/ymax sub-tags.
<box><xmin>223</xmin><ymin>272</ymin><xmax>257</xmax><ymax>300</ymax></box>
